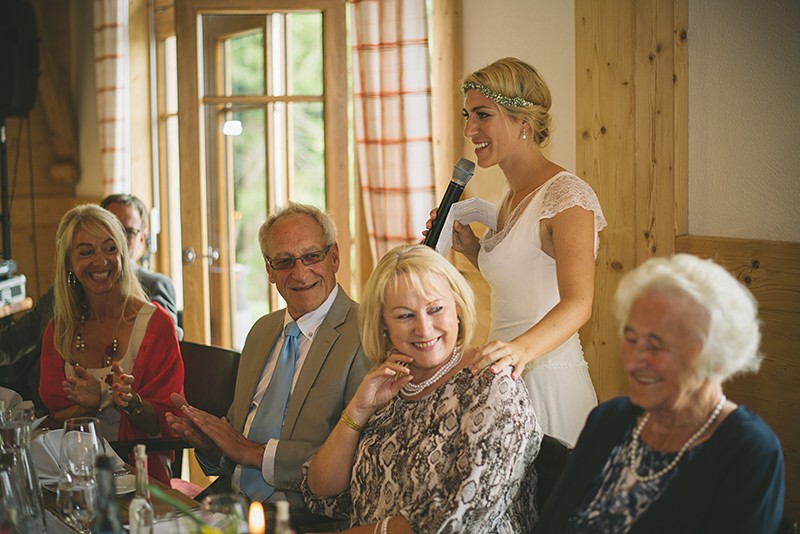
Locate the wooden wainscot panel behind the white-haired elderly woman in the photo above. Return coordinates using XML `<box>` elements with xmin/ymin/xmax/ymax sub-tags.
<box><xmin>675</xmin><ymin>236</ymin><xmax>800</xmax><ymax>518</ymax></box>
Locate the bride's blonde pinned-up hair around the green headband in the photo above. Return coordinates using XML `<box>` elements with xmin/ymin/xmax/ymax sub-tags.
<box><xmin>464</xmin><ymin>57</ymin><xmax>553</xmax><ymax>147</ymax></box>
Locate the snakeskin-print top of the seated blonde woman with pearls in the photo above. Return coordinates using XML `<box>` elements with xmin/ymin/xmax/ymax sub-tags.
<box><xmin>301</xmin><ymin>369</ymin><xmax>542</xmax><ymax>533</ymax></box>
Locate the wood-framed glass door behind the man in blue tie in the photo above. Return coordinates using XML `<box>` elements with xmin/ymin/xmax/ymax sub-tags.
<box><xmin>176</xmin><ymin>0</ymin><xmax>350</xmax><ymax>348</ymax></box>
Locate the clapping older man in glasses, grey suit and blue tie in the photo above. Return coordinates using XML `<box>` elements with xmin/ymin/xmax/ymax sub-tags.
<box><xmin>167</xmin><ymin>203</ymin><xmax>370</xmax><ymax>532</ymax></box>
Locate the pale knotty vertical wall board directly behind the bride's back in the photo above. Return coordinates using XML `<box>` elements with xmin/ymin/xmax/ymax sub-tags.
<box><xmin>575</xmin><ymin>0</ymin><xmax>636</xmax><ymax>401</ymax></box>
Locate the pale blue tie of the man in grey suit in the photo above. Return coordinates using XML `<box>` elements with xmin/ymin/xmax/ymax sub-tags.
<box><xmin>240</xmin><ymin>321</ymin><xmax>300</xmax><ymax>502</ymax></box>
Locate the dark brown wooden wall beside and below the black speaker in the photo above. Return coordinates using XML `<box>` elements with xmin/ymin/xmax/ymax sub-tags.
<box><xmin>6</xmin><ymin>0</ymin><xmax>78</xmax><ymax>301</ymax></box>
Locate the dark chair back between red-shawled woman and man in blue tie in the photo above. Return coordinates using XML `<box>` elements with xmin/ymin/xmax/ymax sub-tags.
<box><xmin>180</xmin><ymin>341</ymin><xmax>240</xmax><ymax>417</ymax></box>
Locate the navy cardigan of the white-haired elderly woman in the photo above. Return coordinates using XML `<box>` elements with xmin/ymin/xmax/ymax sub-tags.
<box><xmin>535</xmin><ymin>397</ymin><xmax>784</xmax><ymax>534</ymax></box>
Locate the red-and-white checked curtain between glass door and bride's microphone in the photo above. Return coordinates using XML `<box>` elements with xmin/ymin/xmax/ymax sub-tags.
<box><xmin>351</xmin><ymin>0</ymin><xmax>435</xmax><ymax>260</ymax></box>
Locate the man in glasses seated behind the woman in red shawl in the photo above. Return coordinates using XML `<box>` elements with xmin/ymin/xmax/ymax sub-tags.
<box><xmin>0</xmin><ymin>195</ymin><xmax>183</xmax><ymax>408</ymax></box>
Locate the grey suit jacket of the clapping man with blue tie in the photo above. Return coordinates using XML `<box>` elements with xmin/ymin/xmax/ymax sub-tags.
<box><xmin>202</xmin><ymin>287</ymin><xmax>371</xmax><ymax>514</ymax></box>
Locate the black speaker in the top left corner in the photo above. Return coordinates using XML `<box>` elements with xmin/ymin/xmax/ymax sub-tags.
<box><xmin>0</xmin><ymin>0</ymin><xmax>39</xmax><ymax>118</ymax></box>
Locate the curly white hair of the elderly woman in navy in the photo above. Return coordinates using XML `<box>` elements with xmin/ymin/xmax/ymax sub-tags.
<box><xmin>614</xmin><ymin>254</ymin><xmax>761</xmax><ymax>382</ymax></box>
